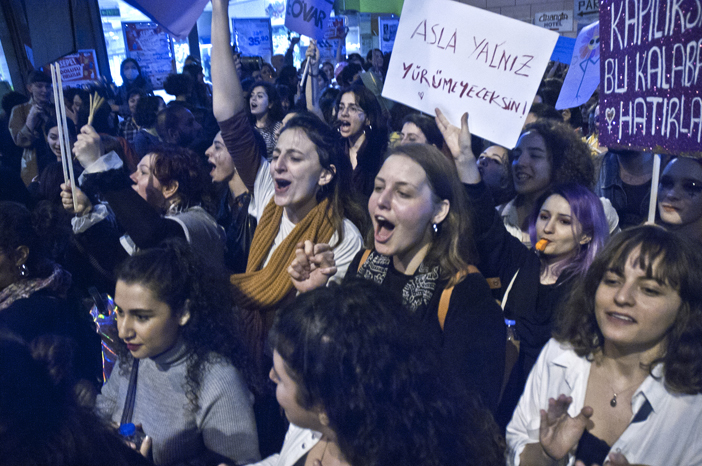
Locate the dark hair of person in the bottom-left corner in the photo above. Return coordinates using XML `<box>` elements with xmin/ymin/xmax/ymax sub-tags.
<box><xmin>0</xmin><ymin>328</ymin><xmax>147</xmax><ymax>466</ymax></box>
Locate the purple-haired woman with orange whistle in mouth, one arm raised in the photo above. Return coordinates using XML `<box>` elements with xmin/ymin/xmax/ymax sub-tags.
<box><xmin>437</xmin><ymin>111</ymin><xmax>609</xmax><ymax>427</ymax></box>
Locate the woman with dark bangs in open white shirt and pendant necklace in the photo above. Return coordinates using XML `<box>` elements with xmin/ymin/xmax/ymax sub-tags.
<box><xmin>507</xmin><ymin>226</ymin><xmax>702</xmax><ymax>466</ymax></box>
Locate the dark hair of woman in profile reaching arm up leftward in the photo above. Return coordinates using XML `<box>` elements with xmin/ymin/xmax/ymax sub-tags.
<box><xmin>150</xmin><ymin>144</ymin><xmax>210</xmax><ymax>207</ymax></box>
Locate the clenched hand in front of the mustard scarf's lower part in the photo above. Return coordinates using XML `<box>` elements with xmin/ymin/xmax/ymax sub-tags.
<box><xmin>288</xmin><ymin>240</ymin><xmax>336</xmax><ymax>293</ymax></box>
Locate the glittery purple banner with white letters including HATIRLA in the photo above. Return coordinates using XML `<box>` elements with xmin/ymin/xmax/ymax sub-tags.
<box><xmin>600</xmin><ymin>0</ymin><xmax>702</xmax><ymax>156</ymax></box>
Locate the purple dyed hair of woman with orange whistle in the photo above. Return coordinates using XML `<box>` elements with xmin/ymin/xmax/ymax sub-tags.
<box><xmin>529</xmin><ymin>183</ymin><xmax>609</xmax><ymax>276</ymax></box>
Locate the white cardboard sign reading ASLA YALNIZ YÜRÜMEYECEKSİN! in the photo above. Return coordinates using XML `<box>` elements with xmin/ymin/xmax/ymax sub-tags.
<box><xmin>383</xmin><ymin>0</ymin><xmax>558</xmax><ymax>148</ymax></box>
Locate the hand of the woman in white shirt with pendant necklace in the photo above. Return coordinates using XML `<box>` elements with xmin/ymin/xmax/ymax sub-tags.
<box><xmin>539</xmin><ymin>395</ymin><xmax>593</xmax><ymax>461</ymax></box>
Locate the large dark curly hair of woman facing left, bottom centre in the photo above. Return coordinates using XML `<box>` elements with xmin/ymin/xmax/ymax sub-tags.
<box><xmin>270</xmin><ymin>279</ymin><xmax>504</xmax><ymax>466</ymax></box>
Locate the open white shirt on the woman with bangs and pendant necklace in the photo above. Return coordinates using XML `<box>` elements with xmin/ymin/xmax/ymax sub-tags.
<box><xmin>507</xmin><ymin>339</ymin><xmax>702</xmax><ymax>466</ymax></box>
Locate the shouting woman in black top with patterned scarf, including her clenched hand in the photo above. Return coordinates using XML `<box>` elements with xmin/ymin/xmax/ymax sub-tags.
<box><xmin>290</xmin><ymin>144</ymin><xmax>505</xmax><ymax>411</ymax></box>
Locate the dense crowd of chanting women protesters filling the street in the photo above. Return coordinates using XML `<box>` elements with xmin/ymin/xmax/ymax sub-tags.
<box><xmin>0</xmin><ymin>0</ymin><xmax>702</xmax><ymax>466</ymax></box>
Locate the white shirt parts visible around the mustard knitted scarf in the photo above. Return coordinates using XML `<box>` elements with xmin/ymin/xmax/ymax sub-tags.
<box><xmin>249</xmin><ymin>160</ymin><xmax>363</xmax><ymax>283</ymax></box>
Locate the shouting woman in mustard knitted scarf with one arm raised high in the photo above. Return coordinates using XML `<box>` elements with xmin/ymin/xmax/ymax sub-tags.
<box><xmin>212</xmin><ymin>0</ymin><xmax>362</xmax><ymax>368</ymax></box>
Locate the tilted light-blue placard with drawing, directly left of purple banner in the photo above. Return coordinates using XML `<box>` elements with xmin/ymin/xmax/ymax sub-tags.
<box><xmin>556</xmin><ymin>22</ymin><xmax>600</xmax><ymax>110</ymax></box>
